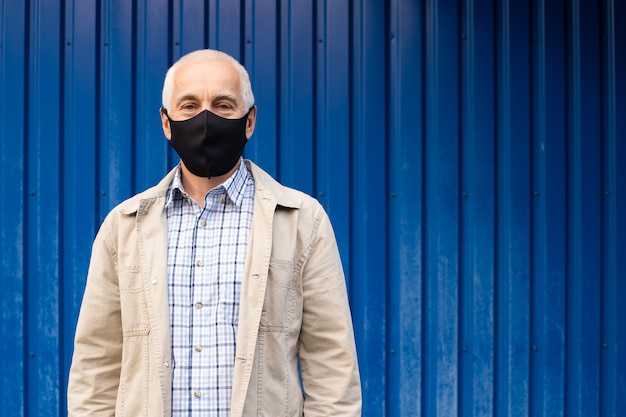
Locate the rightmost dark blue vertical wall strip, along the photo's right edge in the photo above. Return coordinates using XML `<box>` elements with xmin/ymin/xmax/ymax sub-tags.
<box><xmin>601</xmin><ymin>0</ymin><xmax>626</xmax><ymax>416</ymax></box>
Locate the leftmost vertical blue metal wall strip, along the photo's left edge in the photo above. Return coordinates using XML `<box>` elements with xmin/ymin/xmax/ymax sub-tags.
<box><xmin>0</xmin><ymin>1</ymin><xmax>30</xmax><ymax>413</ymax></box>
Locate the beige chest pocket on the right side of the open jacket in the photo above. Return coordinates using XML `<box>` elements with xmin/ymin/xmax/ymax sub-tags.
<box><xmin>261</xmin><ymin>258</ymin><xmax>296</xmax><ymax>332</ymax></box>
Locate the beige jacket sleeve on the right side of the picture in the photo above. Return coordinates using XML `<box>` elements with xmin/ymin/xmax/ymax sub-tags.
<box><xmin>299</xmin><ymin>207</ymin><xmax>361</xmax><ymax>417</ymax></box>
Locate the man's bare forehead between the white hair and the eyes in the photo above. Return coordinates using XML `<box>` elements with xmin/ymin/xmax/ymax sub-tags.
<box><xmin>172</xmin><ymin>60</ymin><xmax>241</xmax><ymax>100</ymax></box>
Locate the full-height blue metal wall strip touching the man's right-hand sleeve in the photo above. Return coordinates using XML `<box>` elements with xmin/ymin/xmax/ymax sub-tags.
<box><xmin>350</xmin><ymin>0</ymin><xmax>387</xmax><ymax>416</ymax></box>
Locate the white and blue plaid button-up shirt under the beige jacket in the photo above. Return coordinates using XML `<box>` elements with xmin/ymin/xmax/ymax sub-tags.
<box><xmin>165</xmin><ymin>162</ymin><xmax>254</xmax><ymax>417</ymax></box>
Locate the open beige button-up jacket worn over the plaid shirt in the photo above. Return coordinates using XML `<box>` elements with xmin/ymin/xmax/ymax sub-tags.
<box><xmin>68</xmin><ymin>161</ymin><xmax>361</xmax><ymax>417</ymax></box>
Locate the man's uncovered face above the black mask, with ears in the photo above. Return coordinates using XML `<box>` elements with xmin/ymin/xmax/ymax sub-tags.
<box><xmin>161</xmin><ymin>60</ymin><xmax>256</xmax><ymax>140</ymax></box>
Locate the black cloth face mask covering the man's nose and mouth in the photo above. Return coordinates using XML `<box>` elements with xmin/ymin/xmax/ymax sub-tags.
<box><xmin>163</xmin><ymin>109</ymin><xmax>250</xmax><ymax>178</ymax></box>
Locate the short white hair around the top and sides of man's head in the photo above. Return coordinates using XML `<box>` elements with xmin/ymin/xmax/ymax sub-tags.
<box><xmin>161</xmin><ymin>49</ymin><xmax>254</xmax><ymax>111</ymax></box>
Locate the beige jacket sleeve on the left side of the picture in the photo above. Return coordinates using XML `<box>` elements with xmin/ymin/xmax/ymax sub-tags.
<box><xmin>67</xmin><ymin>221</ymin><xmax>122</xmax><ymax>417</ymax></box>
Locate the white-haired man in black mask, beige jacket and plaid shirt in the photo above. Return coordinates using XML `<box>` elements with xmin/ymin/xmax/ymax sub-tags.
<box><xmin>68</xmin><ymin>50</ymin><xmax>361</xmax><ymax>417</ymax></box>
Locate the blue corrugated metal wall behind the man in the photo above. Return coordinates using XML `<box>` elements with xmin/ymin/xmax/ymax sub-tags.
<box><xmin>0</xmin><ymin>0</ymin><xmax>626</xmax><ymax>417</ymax></box>
